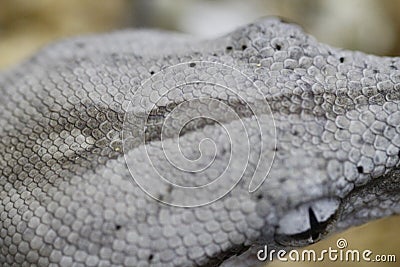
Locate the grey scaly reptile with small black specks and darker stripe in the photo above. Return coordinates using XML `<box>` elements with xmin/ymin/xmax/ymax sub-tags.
<box><xmin>0</xmin><ymin>19</ymin><xmax>400</xmax><ymax>266</ymax></box>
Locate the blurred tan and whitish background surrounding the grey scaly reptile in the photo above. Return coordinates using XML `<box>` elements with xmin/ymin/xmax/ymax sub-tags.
<box><xmin>0</xmin><ymin>0</ymin><xmax>400</xmax><ymax>267</ymax></box>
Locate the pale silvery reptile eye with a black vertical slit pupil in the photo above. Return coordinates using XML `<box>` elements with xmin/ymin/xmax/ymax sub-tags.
<box><xmin>275</xmin><ymin>198</ymin><xmax>340</xmax><ymax>246</ymax></box>
